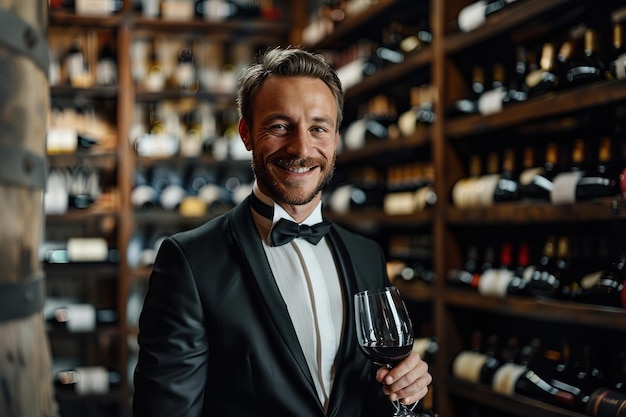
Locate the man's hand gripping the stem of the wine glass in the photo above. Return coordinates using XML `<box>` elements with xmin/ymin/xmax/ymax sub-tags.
<box><xmin>376</xmin><ymin>352</ymin><xmax>433</xmax><ymax>405</ymax></box>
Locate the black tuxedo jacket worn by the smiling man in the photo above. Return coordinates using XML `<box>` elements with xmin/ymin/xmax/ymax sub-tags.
<box><xmin>133</xmin><ymin>198</ymin><xmax>392</xmax><ymax>417</ymax></box>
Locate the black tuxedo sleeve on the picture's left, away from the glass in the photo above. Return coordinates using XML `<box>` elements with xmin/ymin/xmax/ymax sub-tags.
<box><xmin>133</xmin><ymin>238</ymin><xmax>209</xmax><ymax>417</ymax></box>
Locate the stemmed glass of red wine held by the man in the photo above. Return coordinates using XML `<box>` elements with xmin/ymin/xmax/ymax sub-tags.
<box><xmin>354</xmin><ymin>287</ymin><xmax>419</xmax><ymax>417</ymax></box>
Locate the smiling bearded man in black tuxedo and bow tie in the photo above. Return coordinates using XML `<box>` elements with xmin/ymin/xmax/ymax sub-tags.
<box><xmin>133</xmin><ymin>49</ymin><xmax>432</xmax><ymax>417</ymax></box>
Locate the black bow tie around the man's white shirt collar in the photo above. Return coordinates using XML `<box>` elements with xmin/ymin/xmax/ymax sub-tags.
<box><xmin>250</xmin><ymin>193</ymin><xmax>331</xmax><ymax>246</ymax></box>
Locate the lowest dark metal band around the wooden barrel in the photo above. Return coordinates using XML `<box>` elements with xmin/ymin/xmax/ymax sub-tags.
<box><xmin>0</xmin><ymin>271</ymin><xmax>46</xmax><ymax>323</ymax></box>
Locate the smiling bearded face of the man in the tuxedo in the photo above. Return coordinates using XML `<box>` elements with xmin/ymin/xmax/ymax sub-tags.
<box><xmin>239</xmin><ymin>76</ymin><xmax>339</xmax><ymax>205</ymax></box>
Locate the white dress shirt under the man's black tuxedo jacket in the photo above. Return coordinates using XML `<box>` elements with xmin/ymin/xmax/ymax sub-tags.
<box><xmin>252</xmin><ymin>184</ymin><xmax>344</xmax><ymax>409</ymax></box>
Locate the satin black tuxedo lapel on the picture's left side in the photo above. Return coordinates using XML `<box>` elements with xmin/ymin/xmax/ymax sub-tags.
<box><xmin>230</xmin><ymin>197</ymin><xmax>321</xmax><ymax>400</ymax></box>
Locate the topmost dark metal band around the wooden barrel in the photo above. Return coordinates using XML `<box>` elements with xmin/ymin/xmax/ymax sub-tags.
<box><xmin>0</xmin><ymin>7</ymin><xmax>50</xmax><ymax>77</ymax></box>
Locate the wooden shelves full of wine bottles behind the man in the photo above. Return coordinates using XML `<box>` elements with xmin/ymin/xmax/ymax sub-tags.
<box><xmin>40</xmin><ymin>0</ymin><xmax>626</xmax><ymax>417</ymax></box>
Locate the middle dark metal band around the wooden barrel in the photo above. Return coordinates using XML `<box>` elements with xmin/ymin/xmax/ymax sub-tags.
<box><xmin>0</xmin><ymin>144</ymin><xmax>46</xmax><ymax>189</ymax></box>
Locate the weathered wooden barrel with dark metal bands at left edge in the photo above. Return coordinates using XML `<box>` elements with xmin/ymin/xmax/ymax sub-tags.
<box><xmin>0</xmin><ymin>0</ymin><xmax>58</xmax><ymax>417</ymax></box>
